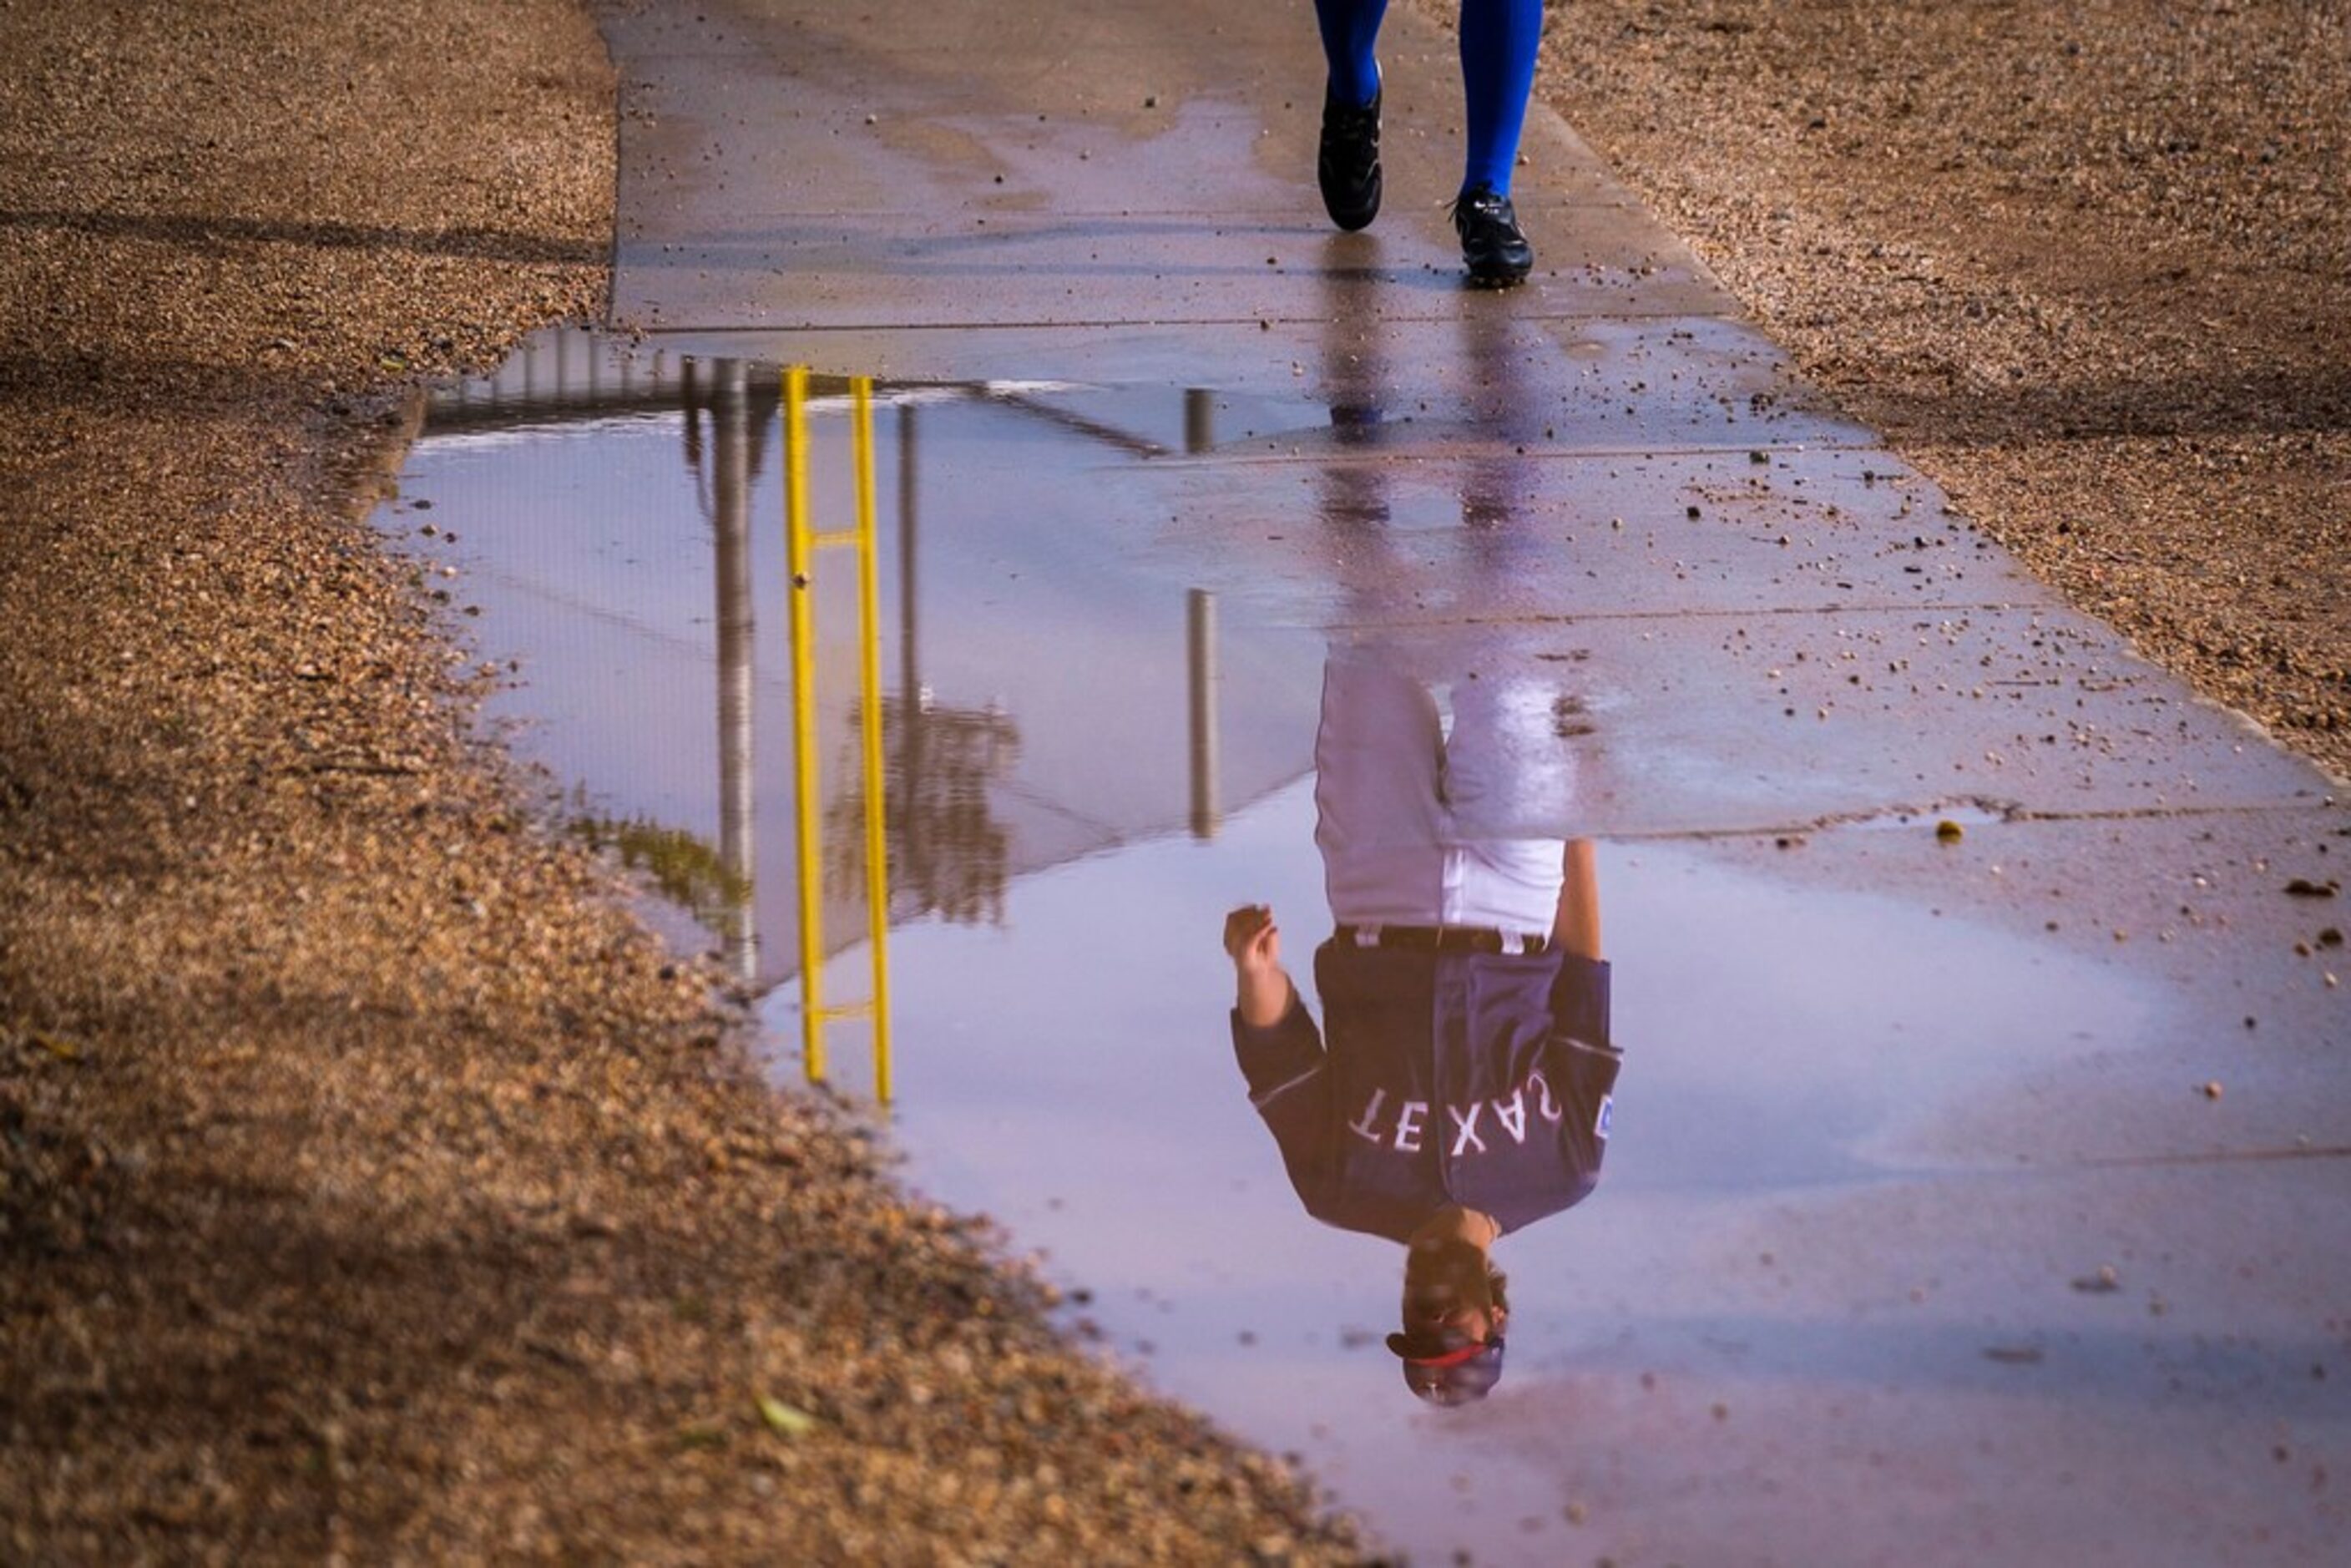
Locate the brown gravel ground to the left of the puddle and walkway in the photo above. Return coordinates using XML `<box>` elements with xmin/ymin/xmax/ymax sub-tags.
<box><xmin>0</xmin><ymin>0</ymin><xmax>1354</xmax><ymax>1563</ymax></box>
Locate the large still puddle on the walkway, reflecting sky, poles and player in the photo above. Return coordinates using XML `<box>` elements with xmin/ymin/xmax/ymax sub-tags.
<box><xmin>383</xmin><ymin>324</ymin><xmax>2158</xmax><ymax>1561</ymax></box>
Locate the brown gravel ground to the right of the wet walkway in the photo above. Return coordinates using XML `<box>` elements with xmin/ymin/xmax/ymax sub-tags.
<box><xmin>1523</xmin><ymin>0</ymin><xmax>2351</xmax><ymax>776</ymax></box>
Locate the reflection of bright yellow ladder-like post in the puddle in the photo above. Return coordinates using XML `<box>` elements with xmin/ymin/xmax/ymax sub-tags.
<box><xmin>783</xmin><ymin>364</ymin><xmax>891</xmax><ymax>1105</ymax></box>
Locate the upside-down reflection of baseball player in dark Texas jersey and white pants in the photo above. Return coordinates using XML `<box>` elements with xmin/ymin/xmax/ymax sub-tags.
<box><xmin>1225</xmin><ymin>654</ymin><xmax>1622</xmax><ymax>1404</ymax></box>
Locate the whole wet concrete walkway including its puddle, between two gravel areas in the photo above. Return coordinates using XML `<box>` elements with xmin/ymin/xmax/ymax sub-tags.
<box><xmin>383</xmin><ymin>5</ymin><xmax>2351</xmax><ymax>1563</ymax></box>
